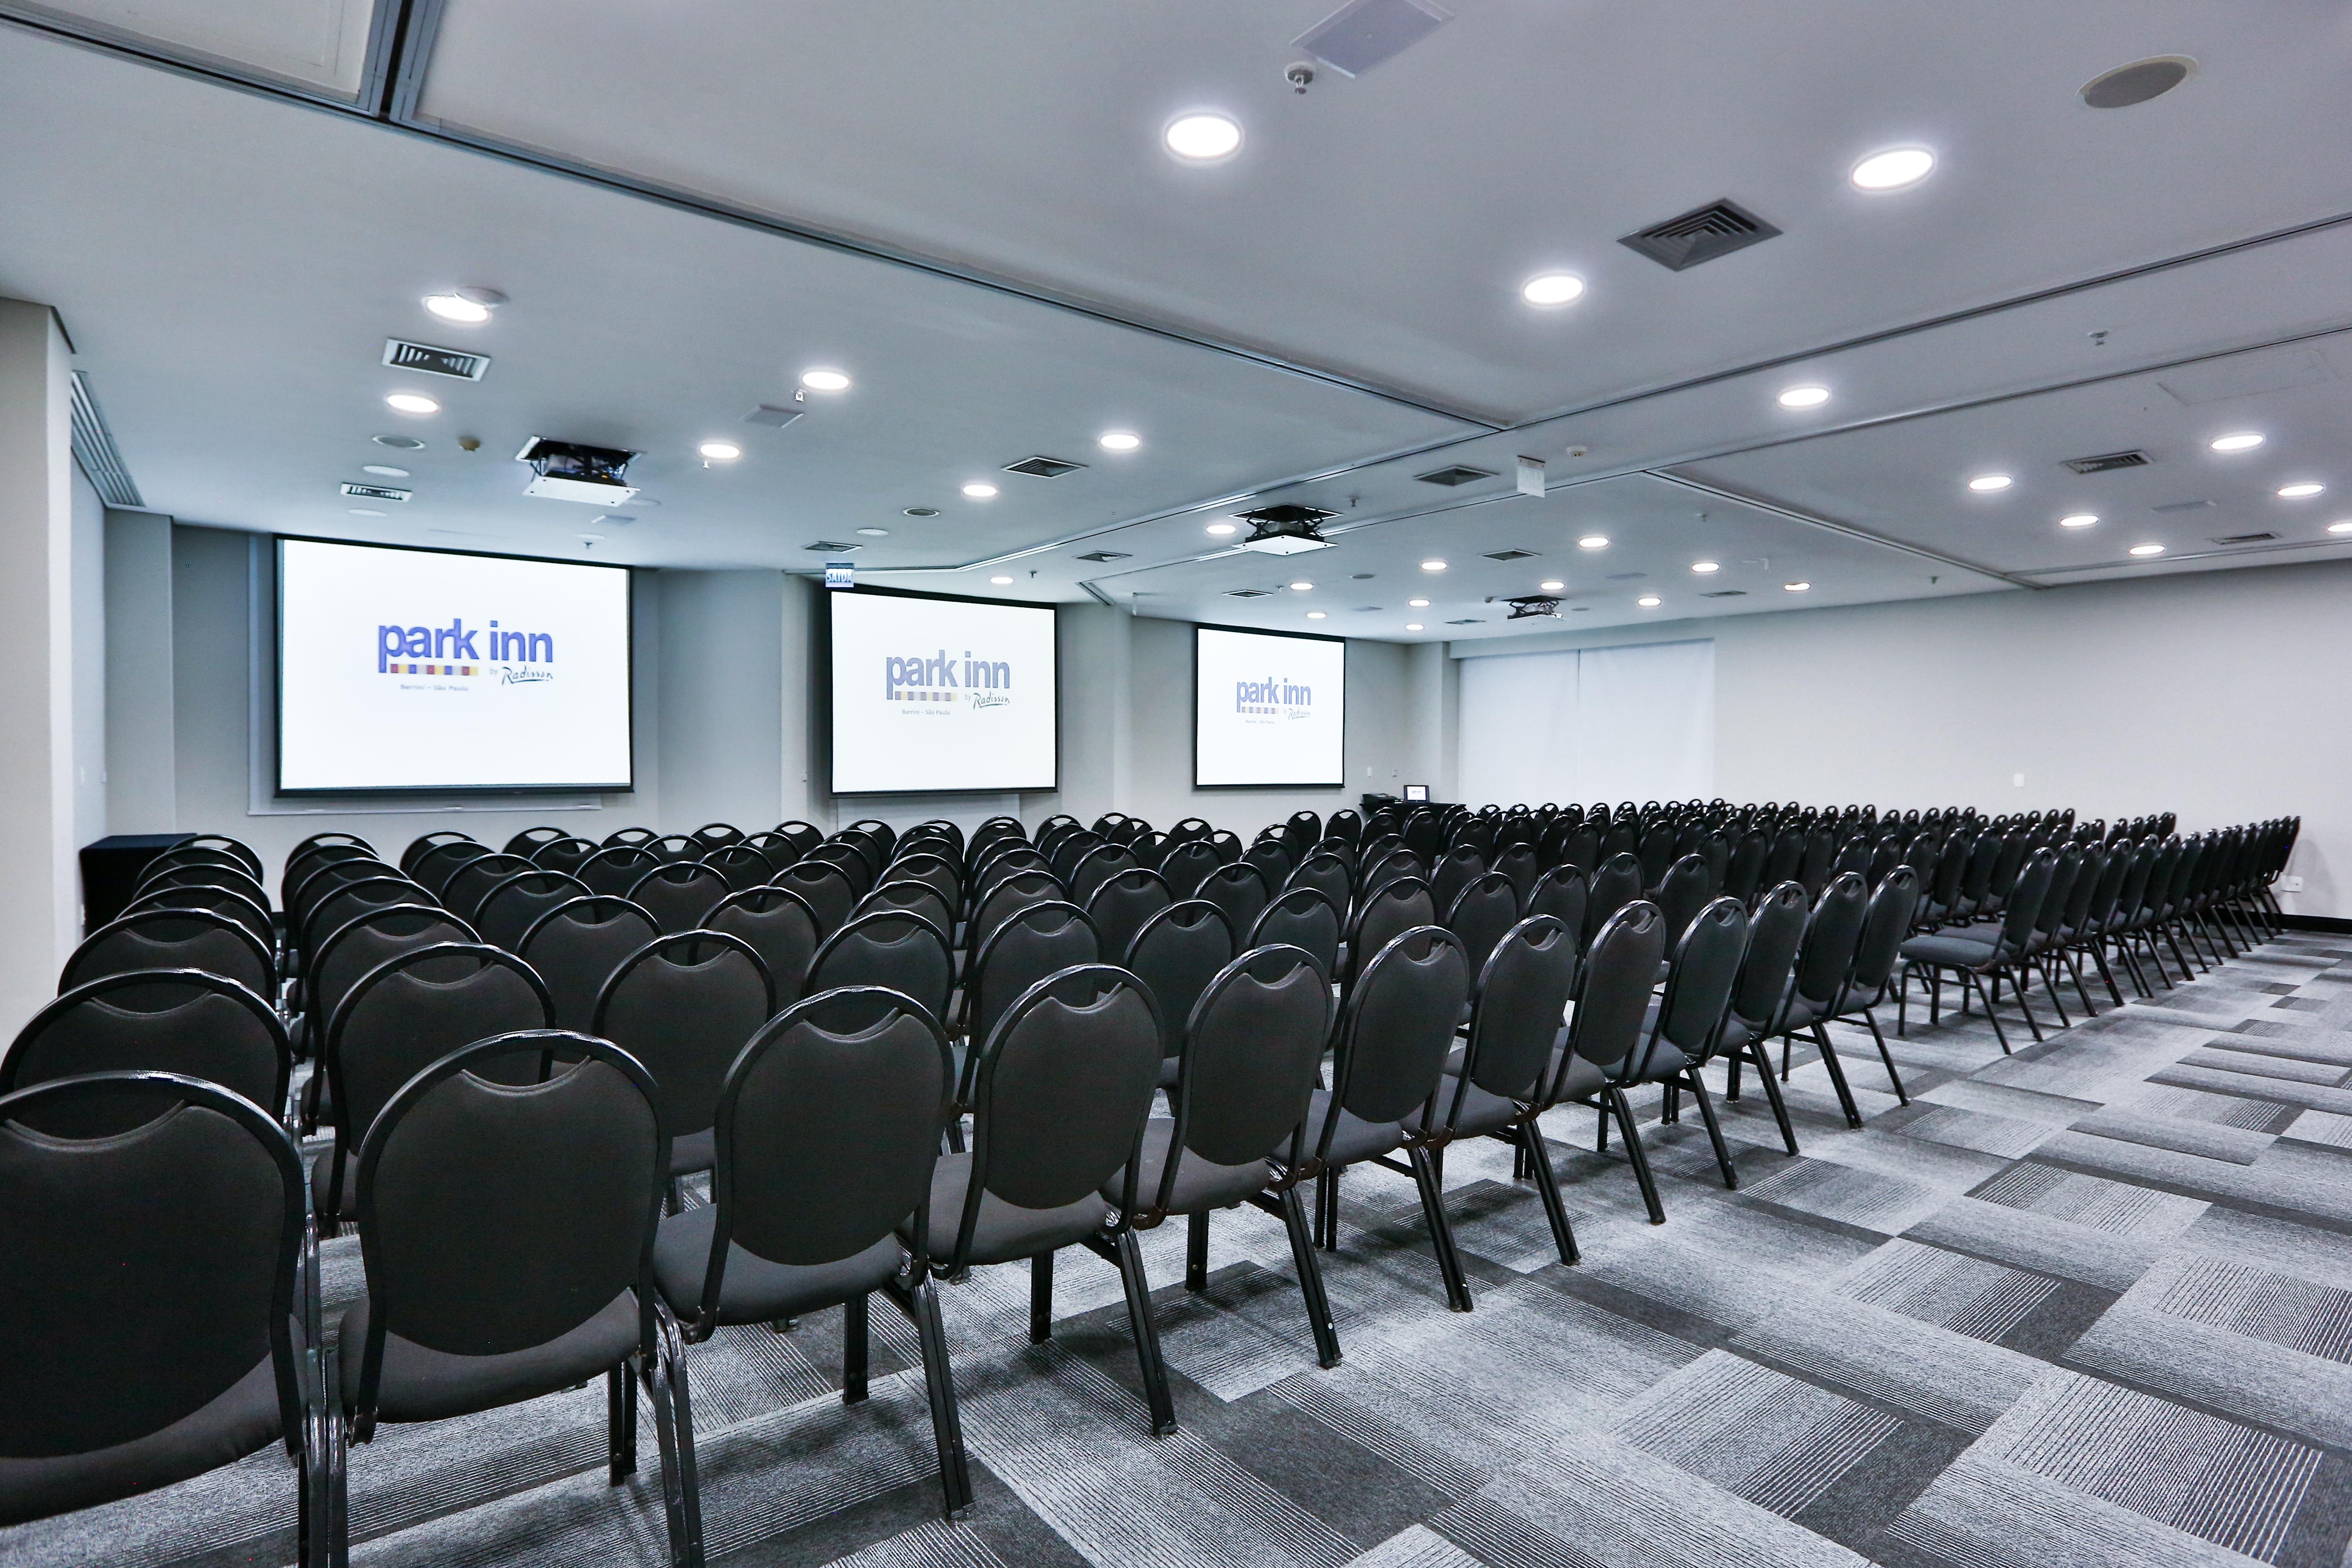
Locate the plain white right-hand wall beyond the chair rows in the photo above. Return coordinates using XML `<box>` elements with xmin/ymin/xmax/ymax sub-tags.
<box><xmin>1451</xmin><ymin>562</ymin><xmax>2352</xmax><ymax>917</ymax></box>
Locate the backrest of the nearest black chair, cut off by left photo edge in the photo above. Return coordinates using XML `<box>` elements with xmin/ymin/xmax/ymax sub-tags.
<box><xmin>0</xmin><ymin>1072</ymin><xmax>308</xmax><ymax>1476</ymax></box>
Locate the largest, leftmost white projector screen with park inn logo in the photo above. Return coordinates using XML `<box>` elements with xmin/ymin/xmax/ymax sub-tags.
<box><xmin>278</xmin><ymin>538</ymin><xmax>635</xmax><ymax>795</ymax></box>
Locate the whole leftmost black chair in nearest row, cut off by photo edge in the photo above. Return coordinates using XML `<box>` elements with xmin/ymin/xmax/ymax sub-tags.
<box><xmin>0</xmin><ymin>1072</ymin><xmax>329</xmax><ymax>1563</ymax></box>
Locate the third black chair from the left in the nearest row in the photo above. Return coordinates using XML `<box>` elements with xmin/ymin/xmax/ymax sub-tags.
<box><xmin>654</xmin><ymin>987</ymin><xmax>972</xmax><ymax>1519</ymax></box>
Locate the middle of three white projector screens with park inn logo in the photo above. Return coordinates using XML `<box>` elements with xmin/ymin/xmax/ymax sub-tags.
<box><xmin>826</xmin><ymin>588</ymin><xmax>1061</xmax><ymax>795</ymax></box>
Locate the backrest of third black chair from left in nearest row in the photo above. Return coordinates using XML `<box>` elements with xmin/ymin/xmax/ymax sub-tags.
<box><xmin>696</xmin><ymin>987</ymin><xmax>955</xmax><ymax>1335</ymax></box>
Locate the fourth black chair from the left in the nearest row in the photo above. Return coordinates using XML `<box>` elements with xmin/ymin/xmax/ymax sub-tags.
<box><xmin>901</xmin><ymin>964</ymin><xmax>1176</xmax><ymax>1436</ymax></box>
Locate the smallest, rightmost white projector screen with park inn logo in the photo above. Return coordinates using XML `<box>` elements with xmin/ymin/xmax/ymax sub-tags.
<box><xmin>1192</xmin><ymin>625</ymin><xmax>1348</xmax><ymax>788</ymax></box>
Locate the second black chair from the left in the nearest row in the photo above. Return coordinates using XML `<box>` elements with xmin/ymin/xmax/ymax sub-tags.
<box><xmin>329</xmin><ymin>1030</ymin><xmax>703</xmax><ymax>1568</ymax></box>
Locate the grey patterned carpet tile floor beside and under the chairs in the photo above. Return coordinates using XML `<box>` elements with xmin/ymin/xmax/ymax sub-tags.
<box><xmin>0</xmin><ymin>936</ymin><xmax>2352</xmax><ymax>1568</ymax></box>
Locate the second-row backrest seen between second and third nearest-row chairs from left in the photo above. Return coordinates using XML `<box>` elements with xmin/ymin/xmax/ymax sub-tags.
<box><xmin>590</xmin><ymin>931</ymin><xmax>776</xmax><ymax>1140</ymax></box>
